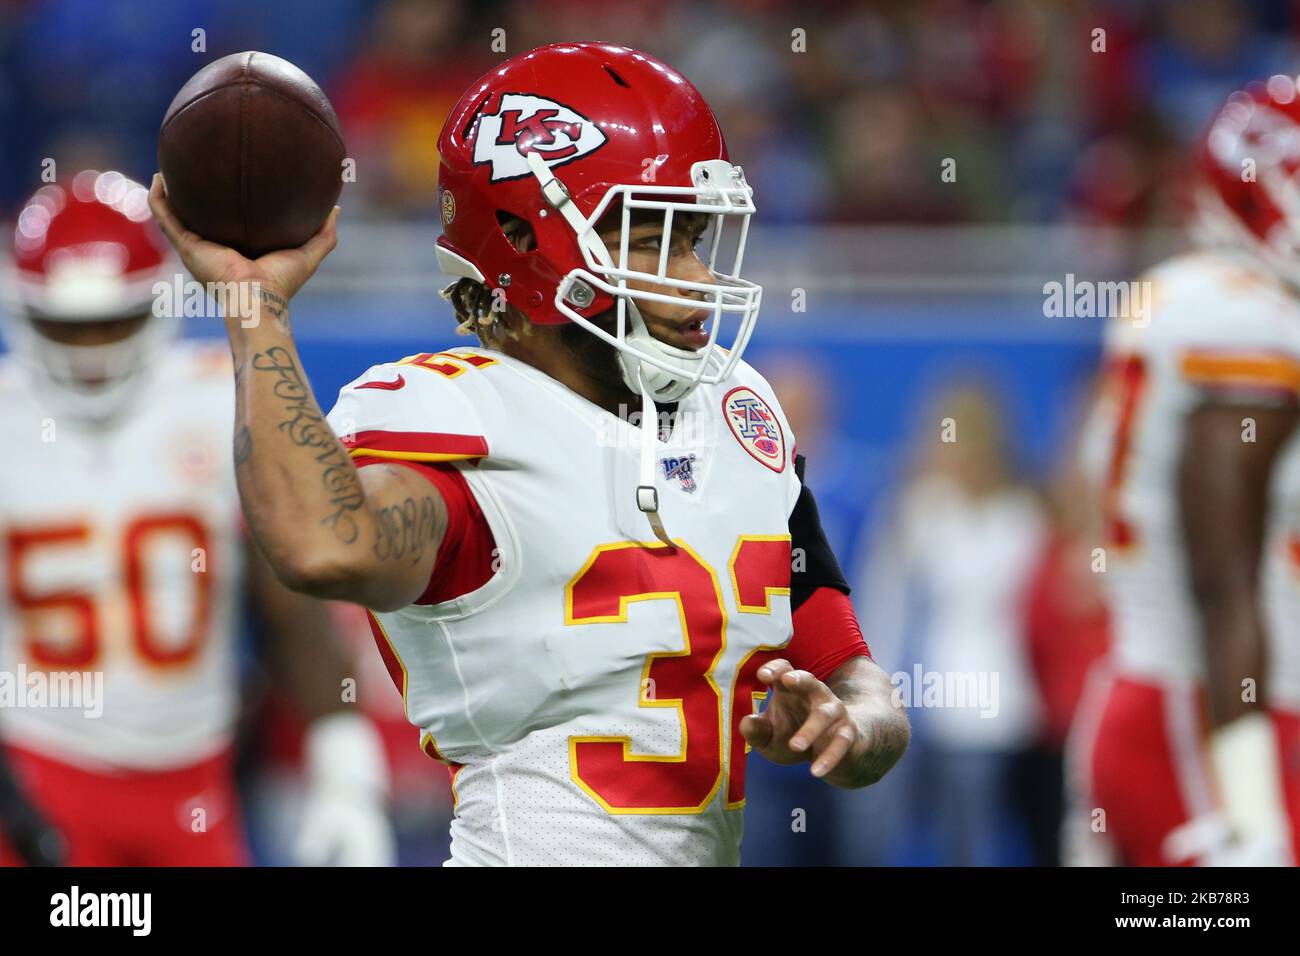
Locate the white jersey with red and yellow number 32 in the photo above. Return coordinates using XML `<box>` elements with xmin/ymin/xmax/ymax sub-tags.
<box><xmin>330</xmin><ymin>349</ymin><xmax>800</xmax><ymax>865</ymax></box>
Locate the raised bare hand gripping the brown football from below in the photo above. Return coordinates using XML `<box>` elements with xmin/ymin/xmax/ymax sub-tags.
<box><xmin>150</xmin><ymin>173</ymin><xmax>338</xmax><ymax>302</ymax></box>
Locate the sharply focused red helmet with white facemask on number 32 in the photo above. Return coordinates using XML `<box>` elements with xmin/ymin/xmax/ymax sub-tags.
<box><xmin>438</xmin><ymin>43</ymin><xmax>762</xmax><ymax>401</ymax></box>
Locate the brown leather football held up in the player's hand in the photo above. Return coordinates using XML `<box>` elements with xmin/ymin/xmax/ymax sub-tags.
<box><xmin>159</xmin><ymin>52</ymin><xmax>346</xmax><ymax>258</ymax></box>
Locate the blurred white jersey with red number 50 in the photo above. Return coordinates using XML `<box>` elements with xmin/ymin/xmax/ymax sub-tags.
<box><xmin>0</xmin><ymin>343</ymin><xmax>243</xmax><ymax>769</ymax></box>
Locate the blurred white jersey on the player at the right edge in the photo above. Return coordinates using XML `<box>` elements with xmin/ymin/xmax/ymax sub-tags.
<box><xmin>1086</xmin><ymin>254</ymin><xmax>1300</xmax><ymax>708</ymax></box>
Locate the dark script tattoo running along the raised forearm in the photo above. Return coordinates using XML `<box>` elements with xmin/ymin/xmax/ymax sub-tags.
<box><xmin>252</xmin><ymin>346</ymin><xmax>365</xmax><ymax>544</ymax></box>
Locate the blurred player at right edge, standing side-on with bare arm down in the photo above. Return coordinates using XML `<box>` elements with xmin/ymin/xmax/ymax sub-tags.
<box><xmin>1071</xmin><ymin>77</ymin><xmax>1300</xmax><ymax>865</ymax></box>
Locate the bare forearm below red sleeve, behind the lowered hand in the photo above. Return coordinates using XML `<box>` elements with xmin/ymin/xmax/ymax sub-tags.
<box><xmin>827</xmin><ymin>666</ymin><xmax>911</xmax><ymax>790</ymax></box>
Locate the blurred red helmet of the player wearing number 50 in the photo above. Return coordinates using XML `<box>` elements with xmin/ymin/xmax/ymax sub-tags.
<box><xmin>0</xmin><ymin>170</ymin><xmax>178</xmax><ymax>421</ymax></box>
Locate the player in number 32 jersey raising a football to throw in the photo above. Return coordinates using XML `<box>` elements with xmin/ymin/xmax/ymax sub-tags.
<box><xmin>151</xmin><ymin>43</ymin><xmax>909</xmax><ymax>865</ymax></box>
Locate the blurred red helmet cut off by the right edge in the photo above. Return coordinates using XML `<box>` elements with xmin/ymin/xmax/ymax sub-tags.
<box><xmin>1193</xmin><ymin>75</ymin><xmax>1300</xmax><ymax>286</ymax></box>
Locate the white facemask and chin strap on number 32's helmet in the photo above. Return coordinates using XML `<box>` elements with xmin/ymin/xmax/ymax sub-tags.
<box><xmin>528</xmin><ymin>153</ymin><xmax>762</xmax><ymax>402</ymax></box>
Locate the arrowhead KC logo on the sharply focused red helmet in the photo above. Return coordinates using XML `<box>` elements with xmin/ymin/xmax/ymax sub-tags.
<box><xmin>475</xmin><ymin>92</ymin><xmax>605</xmax><ymax>182</ymax></box>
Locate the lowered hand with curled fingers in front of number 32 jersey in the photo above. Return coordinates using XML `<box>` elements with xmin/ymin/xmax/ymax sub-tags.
<box><xmin>740</xmin><ymin>658</ymin><xmax>863</xmax><ymax>777</ymax></box>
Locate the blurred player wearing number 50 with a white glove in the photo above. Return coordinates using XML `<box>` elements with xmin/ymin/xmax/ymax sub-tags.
<box><xmin>0</xmin><ymin>172</ymin><xmax>391</xmax><ymax>865</ymax></box>
